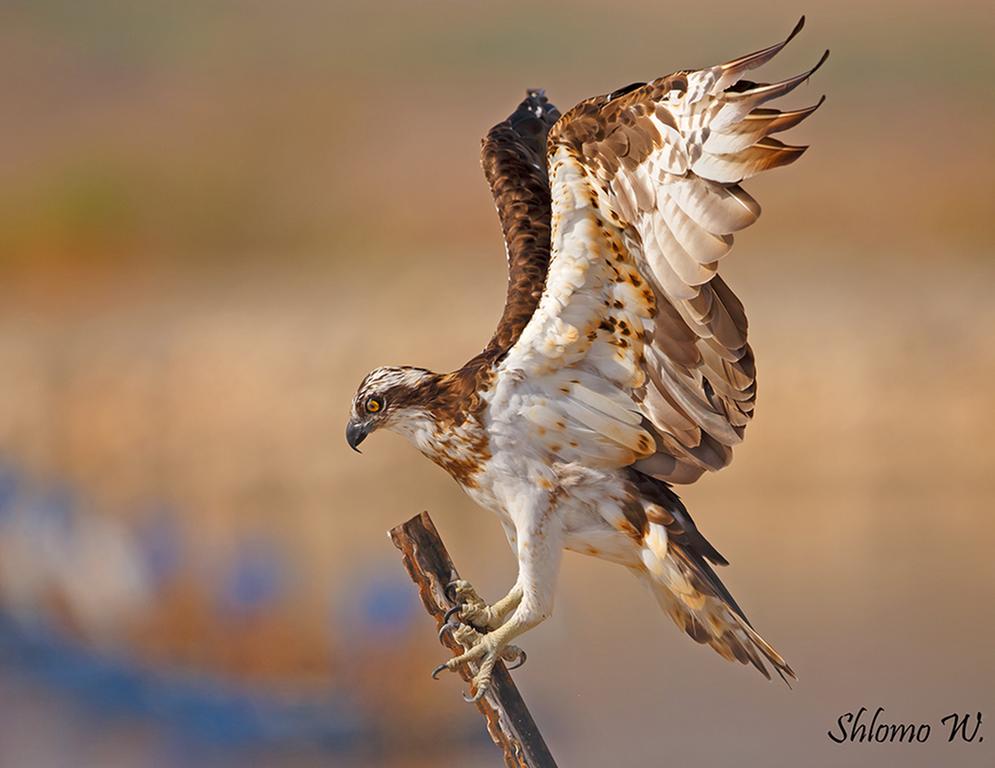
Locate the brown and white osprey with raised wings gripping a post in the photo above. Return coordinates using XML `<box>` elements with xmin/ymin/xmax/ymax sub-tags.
<box><xmin>346</xmin><ymin>17</ymin><xmax>829</xmax><ymax>699</ymax></box>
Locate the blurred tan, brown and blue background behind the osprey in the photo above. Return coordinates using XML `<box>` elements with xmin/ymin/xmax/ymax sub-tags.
<box><xmin>0</xmin><ymin>0</ymin><xmax>995</xmax><ymax>768</ymax></box>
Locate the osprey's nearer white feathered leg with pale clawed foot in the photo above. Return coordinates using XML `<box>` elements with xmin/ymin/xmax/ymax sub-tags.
<box><xmin>432</xmin><ymin>510</ymin><xmax>563</xmax><ymax>701</ymax></box>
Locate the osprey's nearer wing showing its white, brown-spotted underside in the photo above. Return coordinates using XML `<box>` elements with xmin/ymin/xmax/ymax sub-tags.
<box><xmin>497</xmin><ymin>18</ymin><xmax>828</xmax><ymax>483</ymax></box>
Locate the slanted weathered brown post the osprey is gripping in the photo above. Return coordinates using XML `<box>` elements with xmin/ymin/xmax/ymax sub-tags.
<box><xmin>389</xmin><ymin>512</ymin><xmax>556</xmax><ymax>768</ymax></box>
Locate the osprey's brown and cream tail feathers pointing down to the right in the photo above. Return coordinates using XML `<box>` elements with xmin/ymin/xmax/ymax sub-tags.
<box><xmin>639</xmin><ymin>476</ymin><xmax>796</xmax><ymax>683</ymax></box>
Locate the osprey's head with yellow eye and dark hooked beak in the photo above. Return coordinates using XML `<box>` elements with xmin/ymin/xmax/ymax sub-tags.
<box><xmin>345</xmin><ymin>366</ymin><xmax>438</xmax><ymax>451</ymax></box>
